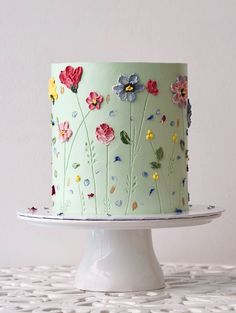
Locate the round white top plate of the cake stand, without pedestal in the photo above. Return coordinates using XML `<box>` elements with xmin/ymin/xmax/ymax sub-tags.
<box><xmin>17</xmin><ymin>205</ymin><xmax>224</xmax><ymax>229</ymax></box>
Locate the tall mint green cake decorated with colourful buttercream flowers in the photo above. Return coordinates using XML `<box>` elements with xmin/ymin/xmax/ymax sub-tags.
<box><xmin>48</xmin><ymin>62</ymin><xmax>191</xmax><ymax>218</ymax></box>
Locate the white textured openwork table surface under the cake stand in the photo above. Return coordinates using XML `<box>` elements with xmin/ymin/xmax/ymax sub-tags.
<box><xmin>0</xmin><ymin>264</ymin><xmax>236</xmax><ymax>313</ymax></box>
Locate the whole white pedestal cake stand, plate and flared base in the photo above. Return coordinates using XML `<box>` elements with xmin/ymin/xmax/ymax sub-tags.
<box><xmin>18</xmin><ymin>205</ymin><xmax>224</xmax><ymax>292</ymax></box>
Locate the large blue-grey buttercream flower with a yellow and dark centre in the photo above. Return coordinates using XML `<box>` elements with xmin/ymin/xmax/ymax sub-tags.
<box><xmin>112</xmin><ymin>74</ymin><xmax>145</xmax><ymax>102</ymax></box>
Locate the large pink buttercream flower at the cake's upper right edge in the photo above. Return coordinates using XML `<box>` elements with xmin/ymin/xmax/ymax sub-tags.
<box><xmin>170</xmin><ymin>75</ymin><xmax>188</xmax><ymax>107</ymax></box>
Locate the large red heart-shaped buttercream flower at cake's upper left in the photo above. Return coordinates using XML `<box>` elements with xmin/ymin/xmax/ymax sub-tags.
<box><xmin>59</xmin><ymin>65</ymin><xmax>83</xmax><ymax>93</ymax></box>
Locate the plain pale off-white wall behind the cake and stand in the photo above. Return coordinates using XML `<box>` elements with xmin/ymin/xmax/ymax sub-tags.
<box><xmin>0</xmin><ymin>0</ymin><xmax>236</xmax><ymax>266</ymax></box>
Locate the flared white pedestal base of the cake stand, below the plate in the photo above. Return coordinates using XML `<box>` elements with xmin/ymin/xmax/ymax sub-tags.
<box><xmin>75</xmin><ymin>229</ymin><xmax>164</xmax><ymax>291</ymax></box>
